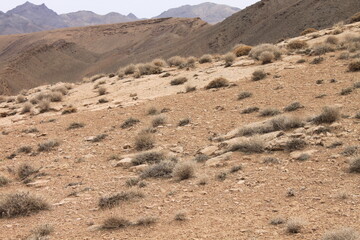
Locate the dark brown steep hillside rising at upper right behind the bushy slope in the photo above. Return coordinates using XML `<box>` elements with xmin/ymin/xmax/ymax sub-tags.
<box><xmin>182</xmin><ymin>0</ymin><xmax>360</xmax><ymax>54</ymax></box>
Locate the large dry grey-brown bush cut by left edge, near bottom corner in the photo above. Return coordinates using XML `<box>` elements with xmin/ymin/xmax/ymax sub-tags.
<box><xmin>0</xmin><ymin>193</ymin><xmax>49</xmax><ymax>218</ymax></box>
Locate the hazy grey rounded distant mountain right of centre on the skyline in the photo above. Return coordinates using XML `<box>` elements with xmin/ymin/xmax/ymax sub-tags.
<box><xmin>155</xmin><ymin>2</ymin><xmax>240</xmax><ymax>24</ymax></box>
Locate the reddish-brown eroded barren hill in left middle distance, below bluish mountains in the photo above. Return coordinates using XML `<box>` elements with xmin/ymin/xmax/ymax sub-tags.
<box><xmin>0</xmin><ymin>19</ymin><xmax>208</xmax><ymax>94</ymax></box>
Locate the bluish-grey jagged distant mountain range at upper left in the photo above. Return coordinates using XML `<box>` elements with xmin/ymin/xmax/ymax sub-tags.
<box><xmin>0</xmin><ymin>2</ymin><xmax>139</xmax><ymax>35</ymax></box>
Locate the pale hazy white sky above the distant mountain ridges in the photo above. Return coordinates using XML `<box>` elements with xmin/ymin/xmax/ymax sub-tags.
<box><xmin>0</xmin><ymin>0</ymin><xmax>259</xmax><ymax>18</ymax></box>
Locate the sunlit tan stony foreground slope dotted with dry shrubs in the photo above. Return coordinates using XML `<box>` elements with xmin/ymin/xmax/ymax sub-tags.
<box><xmin>0</xmin><ymin>20</ymin><xmax>360</xmax><ymax>240</ymax></box>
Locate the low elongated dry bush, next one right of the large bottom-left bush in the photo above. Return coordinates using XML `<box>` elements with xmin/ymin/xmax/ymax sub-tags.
<box><xmin>98</xmin><ymin>191</ymin><xmax>144</xmax><ymax>209</ymax></box>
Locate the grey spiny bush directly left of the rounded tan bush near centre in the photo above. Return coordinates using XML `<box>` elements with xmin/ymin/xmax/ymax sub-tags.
<box><xmin>140</xmin><ymin>161</ymin><xmax>175</xmax><ymax>178</ymax></box>
